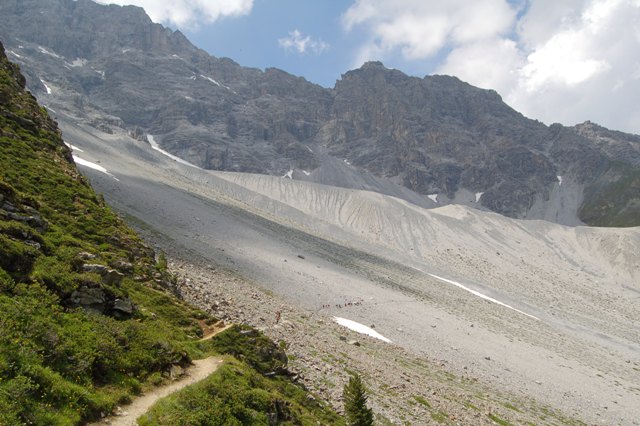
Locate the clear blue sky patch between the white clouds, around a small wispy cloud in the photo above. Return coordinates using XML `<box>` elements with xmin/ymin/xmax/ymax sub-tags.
<box><xmin>183</xmin><ymin>0</ymin><xmax>358</xmax><ymax>87</ymax></box>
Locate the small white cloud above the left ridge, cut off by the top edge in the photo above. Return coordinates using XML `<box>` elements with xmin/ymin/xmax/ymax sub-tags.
<box><xmin>100</xmin><ymin>0</ymin><xmax>253</xmax><ymax>27</ymax></box>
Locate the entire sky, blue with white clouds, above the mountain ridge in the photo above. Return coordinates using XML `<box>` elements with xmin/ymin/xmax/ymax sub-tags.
<box><xmin>105</xmin><ymin>0</ymin><xmax>640</xmax><ymax>134</ymax></box>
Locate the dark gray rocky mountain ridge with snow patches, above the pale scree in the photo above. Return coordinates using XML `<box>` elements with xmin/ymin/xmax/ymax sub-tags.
<box><xmin>0</xmin><ymin>0</ymin><xmax>640</xmax><ymax>225</ymax></box>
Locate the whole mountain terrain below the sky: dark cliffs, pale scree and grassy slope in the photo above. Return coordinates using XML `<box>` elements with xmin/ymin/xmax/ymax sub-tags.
<box><xmin>0</xmin><ymin>0</ymin><xmax>640</xmax><ymax>425</ymax></box>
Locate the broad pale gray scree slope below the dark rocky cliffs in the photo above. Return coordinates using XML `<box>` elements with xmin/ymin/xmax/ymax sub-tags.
<box><xmin>62</xmin><ymin>117</ymin><xmax>640</xmax><ymax>424</ymax></box>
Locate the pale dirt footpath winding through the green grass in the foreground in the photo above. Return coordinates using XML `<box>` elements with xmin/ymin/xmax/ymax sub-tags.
<box><xmin>90</xmin><ymin>357</ymin><xmax>223</xmax><ymax>426</ymax></box>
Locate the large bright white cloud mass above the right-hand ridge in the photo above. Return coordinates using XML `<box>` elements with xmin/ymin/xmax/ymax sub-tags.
<box><xmin>342</xmin><ymin>0</ymin><xmax>640</xmax><ymax>133</ymax></box>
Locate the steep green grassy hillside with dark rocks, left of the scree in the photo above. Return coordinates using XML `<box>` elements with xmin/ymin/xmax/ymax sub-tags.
<box><xmin>0</xmin><ymin>40</ymin><xmax>338</xmax><ymax>425</ymax></box>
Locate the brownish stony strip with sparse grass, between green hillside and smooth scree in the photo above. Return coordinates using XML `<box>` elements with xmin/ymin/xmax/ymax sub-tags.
<box><xmin>171</xmin><ymin>260</ymin><xmax>579</xmax><ymax>425</ymax></box>
